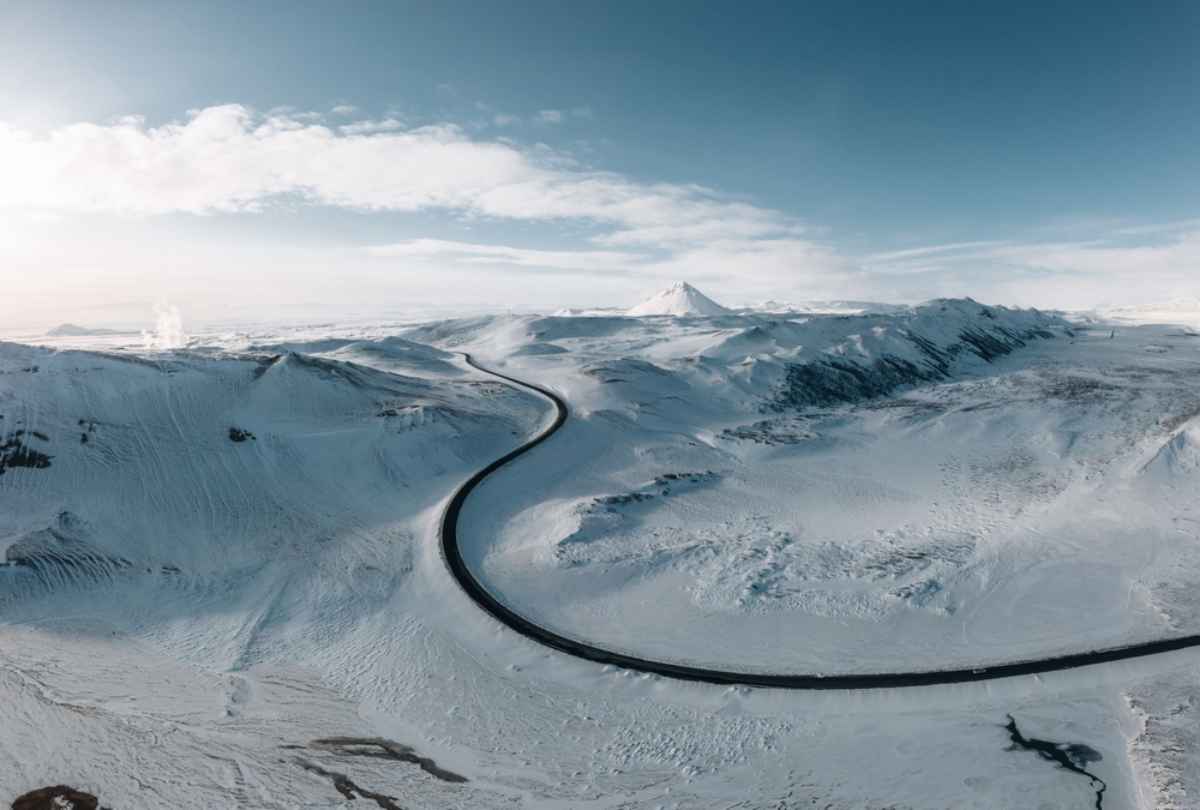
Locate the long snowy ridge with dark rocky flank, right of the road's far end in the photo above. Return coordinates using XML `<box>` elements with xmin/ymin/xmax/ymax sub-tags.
<box><xmin>404</xmin><ymin>299</ymin><xmax>1073</xmax><ymax>419</ymax></box>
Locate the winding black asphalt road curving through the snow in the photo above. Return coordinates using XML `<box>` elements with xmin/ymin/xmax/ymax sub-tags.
<box><xmin>442</xmin><ymin>354</ymin><xmax>1200</xmax><ymax>690</ymax></box>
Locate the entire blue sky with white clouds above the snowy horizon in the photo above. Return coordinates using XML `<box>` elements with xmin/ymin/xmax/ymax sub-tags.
<box><xmin>0</xmin><ymin>1</ymin><xmax>1200</xmax><ymax>320</ymax></box>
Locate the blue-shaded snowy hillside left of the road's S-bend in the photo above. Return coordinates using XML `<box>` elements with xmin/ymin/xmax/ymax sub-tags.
<box><xmin>0</xmin><ymin>343</ymin><xmax>535</xmax><ymax>628</ymax></box>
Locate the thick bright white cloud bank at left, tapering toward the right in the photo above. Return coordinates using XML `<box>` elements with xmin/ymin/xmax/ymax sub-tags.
<box><xmin>0</xmin><ymin>104</ymin><xmax>799</xmax><ymax>255</ymax></box>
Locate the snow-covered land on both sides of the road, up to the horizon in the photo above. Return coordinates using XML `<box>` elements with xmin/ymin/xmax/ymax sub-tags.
<box><xmin>0</xmin><ymin>290</ymin><xmax>1200</xmax><ymax>809</ymax></box>
